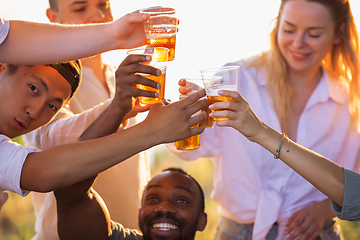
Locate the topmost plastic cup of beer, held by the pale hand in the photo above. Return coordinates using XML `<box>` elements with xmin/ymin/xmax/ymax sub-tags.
<box><xmin>140</xmin><ymin>6</ymin><xmax>178</xmax><ymax>61</ymax></box>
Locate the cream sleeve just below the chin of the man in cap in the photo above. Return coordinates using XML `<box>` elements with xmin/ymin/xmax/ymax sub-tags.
<box><xmin>22</xmin><ymin>99</ymin><xmax>112</xmax><ymax>150</ymax></box>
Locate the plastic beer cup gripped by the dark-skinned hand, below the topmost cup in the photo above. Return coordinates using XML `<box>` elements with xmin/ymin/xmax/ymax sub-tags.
<box><xmin>127</xmin><ymin>47</ymin><xmax>169</xmax><ymax>104</ymax></box>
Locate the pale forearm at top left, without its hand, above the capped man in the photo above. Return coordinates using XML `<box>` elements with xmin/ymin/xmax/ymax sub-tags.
<box><xmin>0</xmin><ymin>20</ymin><xmax>115</xmax><ymax>65</ymax></box>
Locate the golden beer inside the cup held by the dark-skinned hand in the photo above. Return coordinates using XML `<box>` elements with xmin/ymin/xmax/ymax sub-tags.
<box><xmin>136</xmin><ymin>73</ymin><xmax>166</xmax><ymax>104</ymax></box>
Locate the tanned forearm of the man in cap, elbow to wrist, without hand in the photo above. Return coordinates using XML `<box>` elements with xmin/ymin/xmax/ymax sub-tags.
<box><xmin>21</xmin><ymin>121</ymin><xmax>160</xmax><ymax>192</ymax></box>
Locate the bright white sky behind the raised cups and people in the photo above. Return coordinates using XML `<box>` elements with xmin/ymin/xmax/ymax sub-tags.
<box><xmin>0</xmin><ymin>0</ymin><xmax>360</xmax><ymax>96</ymax></box>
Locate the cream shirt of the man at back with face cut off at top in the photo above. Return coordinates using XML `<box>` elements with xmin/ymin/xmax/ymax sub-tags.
<box><xmin>23</xmin><ymin>66</ymin><xmax>150</xmax><ymax>240</ymax></box>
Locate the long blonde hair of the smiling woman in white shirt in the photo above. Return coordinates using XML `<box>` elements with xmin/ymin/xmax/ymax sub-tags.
<box><xmin>249</xmin><ymin>0</ymin><xmax>360</xmax><ymax>126</ymax></box>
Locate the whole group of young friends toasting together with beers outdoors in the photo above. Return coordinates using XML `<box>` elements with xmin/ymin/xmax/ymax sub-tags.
<box><xmin>0</xmin><ymin>0</ymin><xmax>360</xmax><ymax>240</ymax></box>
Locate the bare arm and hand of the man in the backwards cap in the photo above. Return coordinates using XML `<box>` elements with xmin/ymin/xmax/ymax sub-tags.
<box><xmin>20</xmin><ymin>90</ymin><xmax>206</xmax><ymax>192</ymax></box>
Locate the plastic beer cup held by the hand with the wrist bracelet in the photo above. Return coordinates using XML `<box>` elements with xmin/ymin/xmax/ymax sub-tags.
<box><xmin>200</xmin><ymin>66</ymin><xmax>239</xmax><ymax>121</ymax></box>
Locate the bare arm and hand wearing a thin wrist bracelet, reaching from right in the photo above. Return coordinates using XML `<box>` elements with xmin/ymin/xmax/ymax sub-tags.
<box><xmin>212</xmin><ymin>91</ymin><xmax>344</xmax><ymax>206</ymax></box>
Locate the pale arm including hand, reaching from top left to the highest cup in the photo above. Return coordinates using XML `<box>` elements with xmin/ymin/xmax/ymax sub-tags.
<box><xmin>0</xmin><ymin>13</ymin><xmax>148</xmax><ymax>65</ymax></box>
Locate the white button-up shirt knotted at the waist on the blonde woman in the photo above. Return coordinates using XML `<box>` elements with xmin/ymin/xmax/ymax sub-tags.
<box><xmin>167</xmin><ymin>61</ymin><xmax>360</xmax><ymax>240</ymax></box>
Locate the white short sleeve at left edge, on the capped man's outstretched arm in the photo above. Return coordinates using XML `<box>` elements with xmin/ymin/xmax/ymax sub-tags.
<box><xmin>0</xmin><ymin>135</ymin><xmax>37</xmax><ymax>197</ymax></box>
